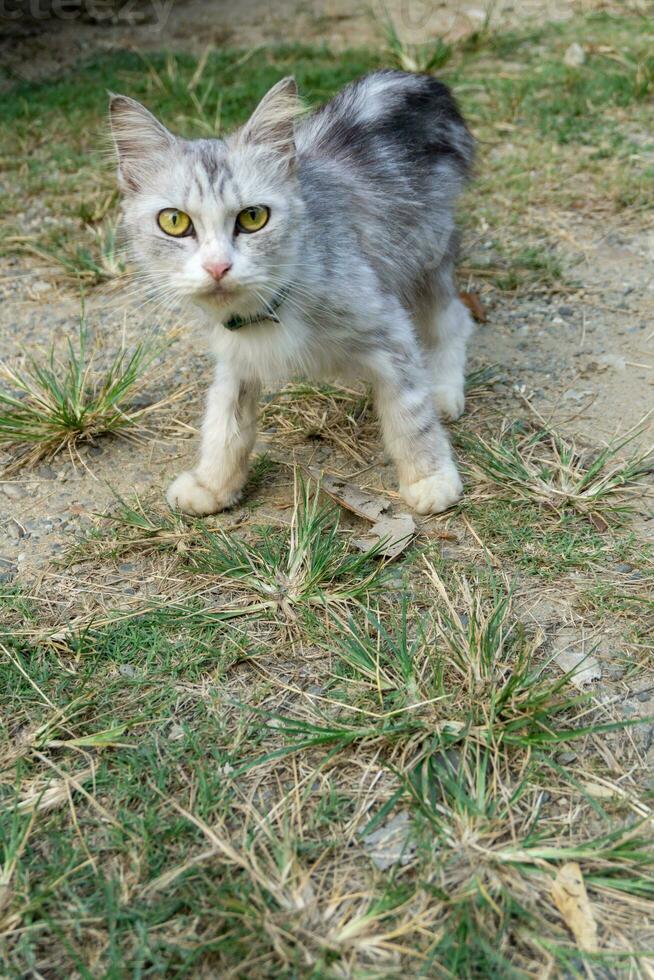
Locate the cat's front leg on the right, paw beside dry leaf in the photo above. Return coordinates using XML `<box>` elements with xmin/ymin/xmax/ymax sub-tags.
<box><xmin>374</xmin><ymin>357</ymin><xmax>463</xmax><ymax>514</ymax></box>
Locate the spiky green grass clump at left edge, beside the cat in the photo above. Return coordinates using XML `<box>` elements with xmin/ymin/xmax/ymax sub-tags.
<box><xmin>0</xmin><ymin>316</ymin><xmax>176</xmax><ymax>472</ymax></box>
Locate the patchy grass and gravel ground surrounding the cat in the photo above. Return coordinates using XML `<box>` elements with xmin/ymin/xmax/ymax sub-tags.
<box><xmin>0</xmin><ymin>0</ymin><xmax>654</xmax><ymax>978</ymax></box>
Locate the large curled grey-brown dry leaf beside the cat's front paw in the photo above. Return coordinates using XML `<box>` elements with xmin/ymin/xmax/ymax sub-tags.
<box><xmin>308</xmin><ymin>466</ymin><xmax>416</xmax><ymax>558</ymax></box>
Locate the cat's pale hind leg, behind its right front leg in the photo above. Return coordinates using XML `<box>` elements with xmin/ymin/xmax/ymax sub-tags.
<box><xmin>425</xmin><ymin>296</ymin><xmax>474</xmax><ymax>420</ymax></box>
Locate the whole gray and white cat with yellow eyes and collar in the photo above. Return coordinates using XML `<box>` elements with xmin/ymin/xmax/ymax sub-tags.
<box><xmin>111</xmin><ymin>71</ymin><xmax>473</xmax><ymax>514</ymax></box>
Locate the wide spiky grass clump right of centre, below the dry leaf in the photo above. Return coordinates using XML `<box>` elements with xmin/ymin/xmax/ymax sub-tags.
<box><xmin>284</xmin><ymin>562</ymin><xmax>616</xmax><ymax>751</ymax></box>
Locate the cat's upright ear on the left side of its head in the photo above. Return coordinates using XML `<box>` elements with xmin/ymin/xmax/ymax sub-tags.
<box><xmin>109</xmin><ymin>93</ymin><xmax>176</xmax><ymax>191</ymax></box>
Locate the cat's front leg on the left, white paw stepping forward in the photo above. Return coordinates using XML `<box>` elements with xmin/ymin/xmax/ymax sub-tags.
<box><xmin>166</xmin><ymin>364</ymin><xmax>259</xmax><ymax>517</ymax></box>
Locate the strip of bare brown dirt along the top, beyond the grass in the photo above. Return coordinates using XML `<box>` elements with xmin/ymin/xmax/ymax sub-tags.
<box><xmin>0</xmin><ymin>0</ymin><xmax>647</xmax><ymax>79</ymax></box>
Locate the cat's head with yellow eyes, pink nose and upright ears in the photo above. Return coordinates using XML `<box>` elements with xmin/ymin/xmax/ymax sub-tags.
<box><xmin>110</xmin><ymin>78</ymin><xmax>304</xmax><ymax>319</ymax></box>
